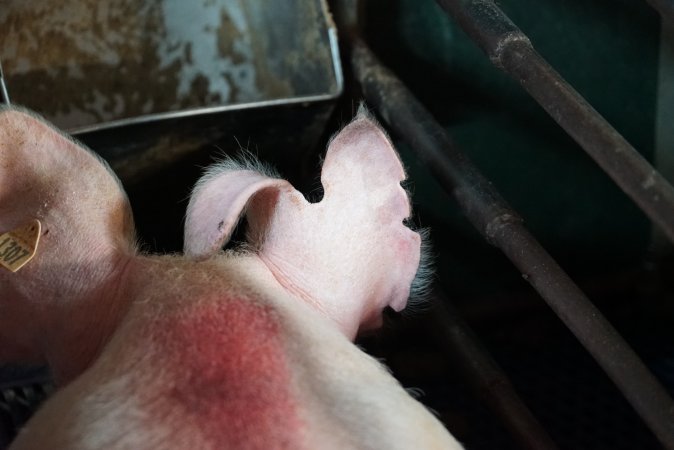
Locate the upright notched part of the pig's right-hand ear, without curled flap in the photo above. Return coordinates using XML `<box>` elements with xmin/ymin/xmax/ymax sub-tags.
<box><xmin>248</xmin><ymin>110</ymin><xmax>421</xmax><ymax>328</ymax></box>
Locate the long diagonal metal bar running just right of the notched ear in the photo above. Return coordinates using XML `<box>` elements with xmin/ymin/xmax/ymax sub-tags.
<box><xmin>351</xmin><ymin>39</ymin><xmax>674</xmax><ymax>449</ymax></box>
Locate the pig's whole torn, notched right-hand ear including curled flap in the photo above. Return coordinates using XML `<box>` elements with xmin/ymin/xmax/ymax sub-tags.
<box><xmin>185</xmin><ymin>110</ymin><xmax>421</xmax><ymax>338</ymax></box>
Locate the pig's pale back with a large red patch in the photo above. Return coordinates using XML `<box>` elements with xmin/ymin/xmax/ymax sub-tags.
<box><xmin>12</xmin><ymin>256</ymin><xmax>457</xmax><ymax>450</ymax></box>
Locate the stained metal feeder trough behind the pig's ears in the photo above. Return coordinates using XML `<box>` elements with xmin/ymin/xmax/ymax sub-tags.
<box><xmin>0</xmin><ymin>0</ymin><xmax>342</xmax><ymax>250</ymax></box>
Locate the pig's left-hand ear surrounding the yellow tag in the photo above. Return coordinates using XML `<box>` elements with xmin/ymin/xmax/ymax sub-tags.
<box><xmin>0</xmin><ymin>107</ymin><xmax>134</xmax><ymax>378</ymax></box>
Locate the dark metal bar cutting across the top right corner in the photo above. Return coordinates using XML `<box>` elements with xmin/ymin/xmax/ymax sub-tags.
<box><xmin>437</xmin><ymin>0</ymin><xmax>674</xmax><ymax>246</ymax></box>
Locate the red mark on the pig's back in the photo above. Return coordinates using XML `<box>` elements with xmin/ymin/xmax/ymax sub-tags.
<box><xmin>152</xmin><ymin>299</ymin><xmax>302</xmax><ymax>449</ymax></box>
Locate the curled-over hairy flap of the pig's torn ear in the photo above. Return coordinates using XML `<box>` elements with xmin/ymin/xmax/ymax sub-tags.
<box><xmin>185</xmin><ymin>155</ymin><xmax>290</xmax><ymax>259</ymax></box>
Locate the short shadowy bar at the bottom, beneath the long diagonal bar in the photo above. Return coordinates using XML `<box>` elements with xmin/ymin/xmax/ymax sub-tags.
<box><xmin>433</xmin><ymin>295</ymin><xmax>558</xmax><ymax>450</ymax></box>
